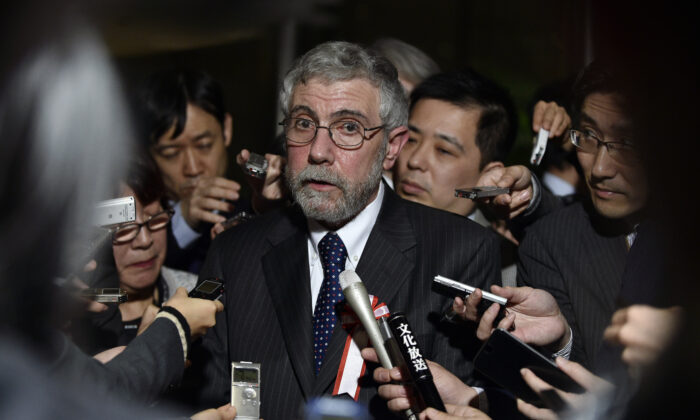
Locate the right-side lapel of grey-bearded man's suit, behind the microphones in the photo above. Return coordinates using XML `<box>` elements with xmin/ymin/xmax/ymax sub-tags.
<box><xmin>314</xmin><ymin>188</ymin><xmax>416</xmax><ymax>394</ymax></box>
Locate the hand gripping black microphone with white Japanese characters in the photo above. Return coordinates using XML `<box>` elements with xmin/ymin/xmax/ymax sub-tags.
<box><xmin>362</xmin><ymin>347</ymin><xmax>478</xmax><ymax>413</ymax></box>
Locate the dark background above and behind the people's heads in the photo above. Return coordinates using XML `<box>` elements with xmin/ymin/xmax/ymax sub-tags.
<box><xmin>80</xmin><ymin>0</ymin><xmax>697</xmax><ymax>202</ymax></box>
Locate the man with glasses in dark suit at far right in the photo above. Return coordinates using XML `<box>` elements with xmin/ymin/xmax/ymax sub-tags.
<box><xmin>518</xmin><ymin>63</ymin><xmax>648</xmax><ymax>367</ymax></box>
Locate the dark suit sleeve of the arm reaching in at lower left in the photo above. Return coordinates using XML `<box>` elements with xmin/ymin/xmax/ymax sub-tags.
<box><xmin>50</xmin><ymin>319</ymin><xmax>185</xmax><ymax>404</ymax></box>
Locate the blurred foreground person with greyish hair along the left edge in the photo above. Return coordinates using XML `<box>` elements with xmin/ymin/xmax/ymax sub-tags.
<box><xmin>0</xmin><ymin>4</ymin><xmax>235</xmax><ymax>419</ymax></box>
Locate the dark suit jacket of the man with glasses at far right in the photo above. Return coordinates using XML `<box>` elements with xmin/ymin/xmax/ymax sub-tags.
<box><xmin>518</xmin><ymin>201</ymin><xmax>627</xmax><ymax>368</ymax></box>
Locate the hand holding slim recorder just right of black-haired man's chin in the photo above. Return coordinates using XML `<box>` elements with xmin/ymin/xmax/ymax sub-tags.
<box><xmin>477</xmin><ymin>165</ymin><xmax>533</xmax><ymax>220</ymax></box>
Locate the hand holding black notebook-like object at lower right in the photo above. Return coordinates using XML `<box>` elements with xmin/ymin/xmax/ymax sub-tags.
<box><xmin>518</xmin><ymin>357</ymin><xmax>613</xmax><ymax>419</ymax></box>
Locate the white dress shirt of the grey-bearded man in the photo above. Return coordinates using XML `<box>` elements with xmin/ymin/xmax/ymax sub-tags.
<box><xmin>307</xmin><ymin>182</ymin><xmax>384</xmax><ymax>314</ymax></box>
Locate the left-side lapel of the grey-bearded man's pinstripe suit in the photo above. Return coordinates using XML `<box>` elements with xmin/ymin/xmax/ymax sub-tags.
<box><xmin>262</xmin><ymin>208</ymin><xmax>314</xmax><ymax>398</ymax></box>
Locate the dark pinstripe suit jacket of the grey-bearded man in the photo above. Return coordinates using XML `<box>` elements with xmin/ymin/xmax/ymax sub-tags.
<box><xmin>186</xmin><ymin>188</ymin><xmax>500</xmax><ymax>420</ymax></box>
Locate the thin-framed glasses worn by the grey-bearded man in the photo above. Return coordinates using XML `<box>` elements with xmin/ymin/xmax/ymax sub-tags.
<box><xmin>279</xmin><ymin>118</ymin><xmax>384</xmax><ymax>150</ymax></box>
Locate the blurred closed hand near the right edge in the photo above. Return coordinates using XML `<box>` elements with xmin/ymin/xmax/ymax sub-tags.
<box><xmin>603</xmin><ymin>305</ymin><xmax>682</xmax><ymax>368</ymax></box>
